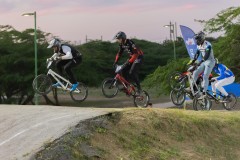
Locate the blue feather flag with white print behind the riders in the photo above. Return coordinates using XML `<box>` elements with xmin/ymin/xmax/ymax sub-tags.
<box><xmin>180</xmin><ymin>25</ymin><xmax>197</xmax><ymax>59</ymax></box>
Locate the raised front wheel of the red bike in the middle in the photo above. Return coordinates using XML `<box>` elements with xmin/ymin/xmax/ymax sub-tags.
<box><xmin>102</xmin><ymin>78</ymin><xmax>119</xmax><ymax>98</ymax></box>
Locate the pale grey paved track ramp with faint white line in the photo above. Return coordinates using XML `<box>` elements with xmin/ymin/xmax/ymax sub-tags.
<box><xmin>0</xmin><ymin>105</ymin><xmax>121</xmax><ymax>160</ymax></box>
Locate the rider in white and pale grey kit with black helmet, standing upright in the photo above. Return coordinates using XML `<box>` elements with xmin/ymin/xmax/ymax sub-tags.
<box><xmin>191</xmin><ymin>31</ymin><xmax>215</xmax><ymax>99</ymax></box>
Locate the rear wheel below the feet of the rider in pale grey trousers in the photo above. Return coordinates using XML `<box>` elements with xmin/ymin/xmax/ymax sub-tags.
<box><xmin>193</xmin><ymin>96</ymin><xmax>212</xmax><ymax>111</ymax></box>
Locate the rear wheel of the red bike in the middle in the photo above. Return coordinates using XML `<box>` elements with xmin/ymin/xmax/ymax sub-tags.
<box><xmin>133</xmin><ymin>90</ymin><xmax>150</xmax><ymax>108</ymax></box>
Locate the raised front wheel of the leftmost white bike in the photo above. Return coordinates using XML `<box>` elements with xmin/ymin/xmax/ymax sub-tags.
<box><xmin>32</xmin><ymin>74</ymin><xmax>52</xmax><ymax>95</ymax></box>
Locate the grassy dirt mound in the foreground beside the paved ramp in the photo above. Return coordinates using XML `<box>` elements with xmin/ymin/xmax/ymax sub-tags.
<box><xmin>31</xmin><ymin>108</ymin><xmax>240</xmax><ymax>160</ymax></box>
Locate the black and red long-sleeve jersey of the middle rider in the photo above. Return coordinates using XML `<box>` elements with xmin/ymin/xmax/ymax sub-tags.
<box><xmin>115</xmin><ymin>39</ymin><xmax>143</xmax><ymax>63</ymax></box>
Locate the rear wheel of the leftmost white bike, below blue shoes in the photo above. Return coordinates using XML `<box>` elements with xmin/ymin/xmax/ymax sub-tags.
<box><xmin>70</xmin><ymin>82</ymin><xmax>88</xmax><ymax>102</ymax></box>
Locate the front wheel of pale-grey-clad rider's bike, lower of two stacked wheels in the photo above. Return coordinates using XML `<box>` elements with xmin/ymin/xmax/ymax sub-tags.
<box><xmin>170</xmin><ymin>89</ymin><xmax>186</xmax><ymax>106</ymax></box>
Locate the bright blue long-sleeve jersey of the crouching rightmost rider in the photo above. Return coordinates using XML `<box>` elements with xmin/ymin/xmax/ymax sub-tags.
<box><xmin>213</xmin><ymin>64</ymin><xmax>234</xmax><ymax>80</ymax></box>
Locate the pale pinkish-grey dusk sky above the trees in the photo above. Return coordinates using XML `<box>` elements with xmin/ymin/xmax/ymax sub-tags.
<box><xmin>0</xmin><ymin>0</ymin><xmax>240</xmax><ymax>44</ymax></box>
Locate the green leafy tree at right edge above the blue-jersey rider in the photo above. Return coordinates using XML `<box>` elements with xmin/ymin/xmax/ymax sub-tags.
<box><xmin>205</xmin><ymin>7</ymin><xmax>240</xmax><ymax>80</ymax></box>
